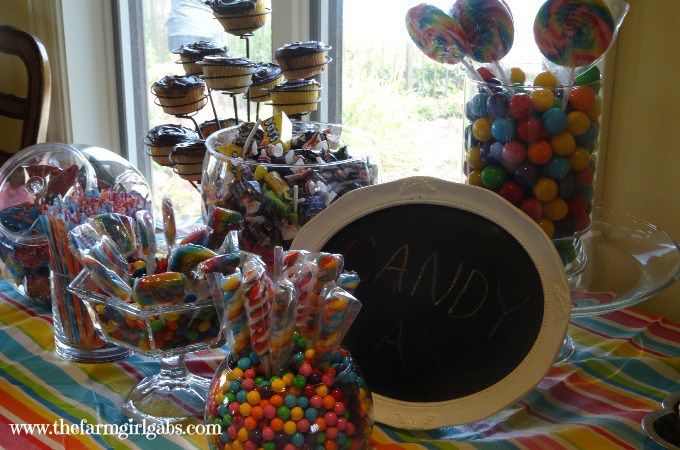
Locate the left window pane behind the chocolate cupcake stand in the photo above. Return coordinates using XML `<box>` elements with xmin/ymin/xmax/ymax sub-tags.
<box><xmin>143</xmin><ymin>0</ymin><xmax>272</xmax><ymax>224</ymax></box>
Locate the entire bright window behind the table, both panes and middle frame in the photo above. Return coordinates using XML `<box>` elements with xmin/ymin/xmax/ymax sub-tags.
<box><xmin>119</xmin><ymin>0</ymin><xmax>596</xmax><ymax>219</ymax></box>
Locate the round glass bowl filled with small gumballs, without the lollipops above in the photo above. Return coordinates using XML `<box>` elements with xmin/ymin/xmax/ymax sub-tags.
<box><xmin>205</xmin><ymin>348</ymin><xmax>373</xmax><ymax>449</ymax></box>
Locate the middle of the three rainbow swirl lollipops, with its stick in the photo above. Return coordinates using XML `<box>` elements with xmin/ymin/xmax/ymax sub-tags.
<box><xmin>451</xmin><ymin>0</ymin><xmax>515</xmax><ymax>86</ymax></box>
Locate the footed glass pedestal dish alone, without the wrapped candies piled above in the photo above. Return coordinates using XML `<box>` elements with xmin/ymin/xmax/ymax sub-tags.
<box><xmin>69</xmin><ymin>270</ymin><xmax>225</xmax><ymax>424</ymax></box>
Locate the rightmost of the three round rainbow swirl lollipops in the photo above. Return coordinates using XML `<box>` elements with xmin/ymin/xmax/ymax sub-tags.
<box><xmin>534</xmin><ymin>0</ymin><xmax>614</xmax><ymax>68</ymax></box>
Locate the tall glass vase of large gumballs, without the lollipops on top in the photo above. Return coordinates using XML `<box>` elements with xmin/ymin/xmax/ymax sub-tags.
<box><xmin>464</xmin><ymin>66</ymin><xmax>602</xmax><ymax>273</ymax></box>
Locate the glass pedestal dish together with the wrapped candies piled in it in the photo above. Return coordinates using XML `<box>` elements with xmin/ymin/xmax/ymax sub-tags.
<box><xmin>69</xmin><ymin>206</ymin><xmax>241</xmax><ymax>423</ymax></box>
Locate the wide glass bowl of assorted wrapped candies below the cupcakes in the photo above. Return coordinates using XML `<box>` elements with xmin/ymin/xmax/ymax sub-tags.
<box><xmin>201</xmin><ymin>112</ymin><xmax>378</xmax><ymax>263</ymax></box>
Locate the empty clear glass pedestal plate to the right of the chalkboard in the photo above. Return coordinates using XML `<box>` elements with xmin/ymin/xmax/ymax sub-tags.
<box><xmin>555</xmin><ymin>208</ymin><xmax>680</xmax><ymax>362</ymax></box>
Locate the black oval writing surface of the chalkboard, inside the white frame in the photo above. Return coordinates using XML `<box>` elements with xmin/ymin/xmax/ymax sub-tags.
<box><xmin>323</xmin><ymin>204</ymin><xmax>543</xmax><ymax>402</ymax></box>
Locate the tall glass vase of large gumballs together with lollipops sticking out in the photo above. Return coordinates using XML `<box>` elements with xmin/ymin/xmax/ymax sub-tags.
<box><xmin>451</xmin><ymin>0</ymin><xmax>628</xmax><ymax>273</ymax></box>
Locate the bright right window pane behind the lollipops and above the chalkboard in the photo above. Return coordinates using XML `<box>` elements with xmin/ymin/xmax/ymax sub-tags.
<box><xmin>342</xmin><ymin>0</ymin><xmax>543</xmax><ymax>181</ymax></box>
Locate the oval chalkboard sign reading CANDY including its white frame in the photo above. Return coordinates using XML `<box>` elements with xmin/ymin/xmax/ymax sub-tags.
<box><xmin>292</xmin><ymin>177</ymin><xmax>571</xmax><ymax>429</ymax></box>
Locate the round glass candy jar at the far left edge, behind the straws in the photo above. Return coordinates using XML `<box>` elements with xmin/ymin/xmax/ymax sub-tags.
<box><xmin>0</xmin><ymin>144</ymin><xmax>96</xmax><ymax>306</ymax></box>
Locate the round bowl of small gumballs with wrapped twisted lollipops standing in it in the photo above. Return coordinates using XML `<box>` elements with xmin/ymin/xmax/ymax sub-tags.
<box><xmin>205</xmin><ymin>247</ymin><xmax>373</xmax><ymax>449</ymax></box>
